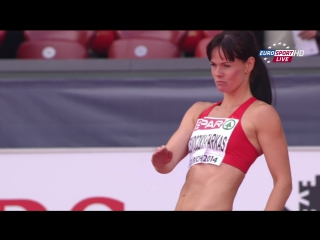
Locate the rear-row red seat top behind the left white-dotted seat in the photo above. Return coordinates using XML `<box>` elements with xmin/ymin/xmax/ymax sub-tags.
<box><xmin>24</xmin><ymin>30</ymin><xmax>94</xmax><ymax>46</ymax></box>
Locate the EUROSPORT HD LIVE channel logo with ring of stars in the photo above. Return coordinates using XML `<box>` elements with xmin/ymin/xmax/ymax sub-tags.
<box><xmin>259</xmin><ymin>42</ymin><xmax>304</xmax><ymax>63</ymax></box>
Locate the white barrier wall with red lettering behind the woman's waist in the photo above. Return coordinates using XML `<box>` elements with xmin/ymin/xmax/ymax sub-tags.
<box><xmin>0</xmin><ymin>147</ymin><xmax>320</xmax><ymax>211</ymax></box>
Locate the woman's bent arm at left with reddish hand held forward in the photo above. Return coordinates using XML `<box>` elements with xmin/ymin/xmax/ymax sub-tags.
<box><xmin>152</xmin><ymin>102</ymin><xmax>203</xmax><ymax>173</ymax></box>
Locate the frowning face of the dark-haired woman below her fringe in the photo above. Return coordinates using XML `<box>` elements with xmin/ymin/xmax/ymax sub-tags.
<box><xmin>210</xmin><ymin>48</ymin><xmax>254</xmax><ymax>93</ymax></box>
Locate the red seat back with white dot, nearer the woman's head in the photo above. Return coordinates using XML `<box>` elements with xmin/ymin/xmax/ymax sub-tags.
<box><xmin>108</xmin><ymin>39</ymin><xmax>181</xmax><ymax>59</ymax></box>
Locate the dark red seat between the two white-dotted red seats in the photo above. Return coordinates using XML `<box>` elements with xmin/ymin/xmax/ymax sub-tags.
<box><xmin>90</xmin><ymin>30</ymin><xmax>116</xmax><ymax>54</ymax></box>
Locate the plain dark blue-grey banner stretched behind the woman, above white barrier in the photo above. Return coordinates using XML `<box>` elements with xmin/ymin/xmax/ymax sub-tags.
<box><xmin>0</xmin><ymin>76</ymin><xmax>320</xmax><ymax>149</ymax></box>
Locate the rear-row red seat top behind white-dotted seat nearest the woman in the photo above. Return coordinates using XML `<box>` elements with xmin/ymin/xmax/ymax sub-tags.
<box><xmin>116</xmin><ymin>30</ymin><xmax>188</xmax><ymax>46</ymax></box>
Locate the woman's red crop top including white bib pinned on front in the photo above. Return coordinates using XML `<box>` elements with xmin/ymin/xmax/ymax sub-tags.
<box><xmin>188</xmin><ymin>97</ymin><xmax>260</xmax><ymax>174</ymax></box>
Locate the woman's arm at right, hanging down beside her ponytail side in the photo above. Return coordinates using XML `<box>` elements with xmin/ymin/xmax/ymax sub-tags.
<box><xmin>254</xmin><ymin>104</ymin><xmax>292</xmax><ymax>211</ymax></box>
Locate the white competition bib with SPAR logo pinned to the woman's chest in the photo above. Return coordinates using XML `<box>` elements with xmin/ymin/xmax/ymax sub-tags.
<box><xmin>188</xmin><ymin>117</ymin><xmax>239</xmax><ymax>168</ymax></box>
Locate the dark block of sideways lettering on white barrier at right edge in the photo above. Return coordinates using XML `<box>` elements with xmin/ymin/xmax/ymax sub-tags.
<box><xmin>284</xmin><ymin>175</ymin><xmax>320</xmax><ymax>211</ymax></box>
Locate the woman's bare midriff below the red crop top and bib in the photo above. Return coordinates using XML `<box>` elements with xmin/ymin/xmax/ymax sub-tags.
<box><xmin>175</xmin><ymin>163</ymin><xmax>245</xmax><ymax>211</ymax></box>
